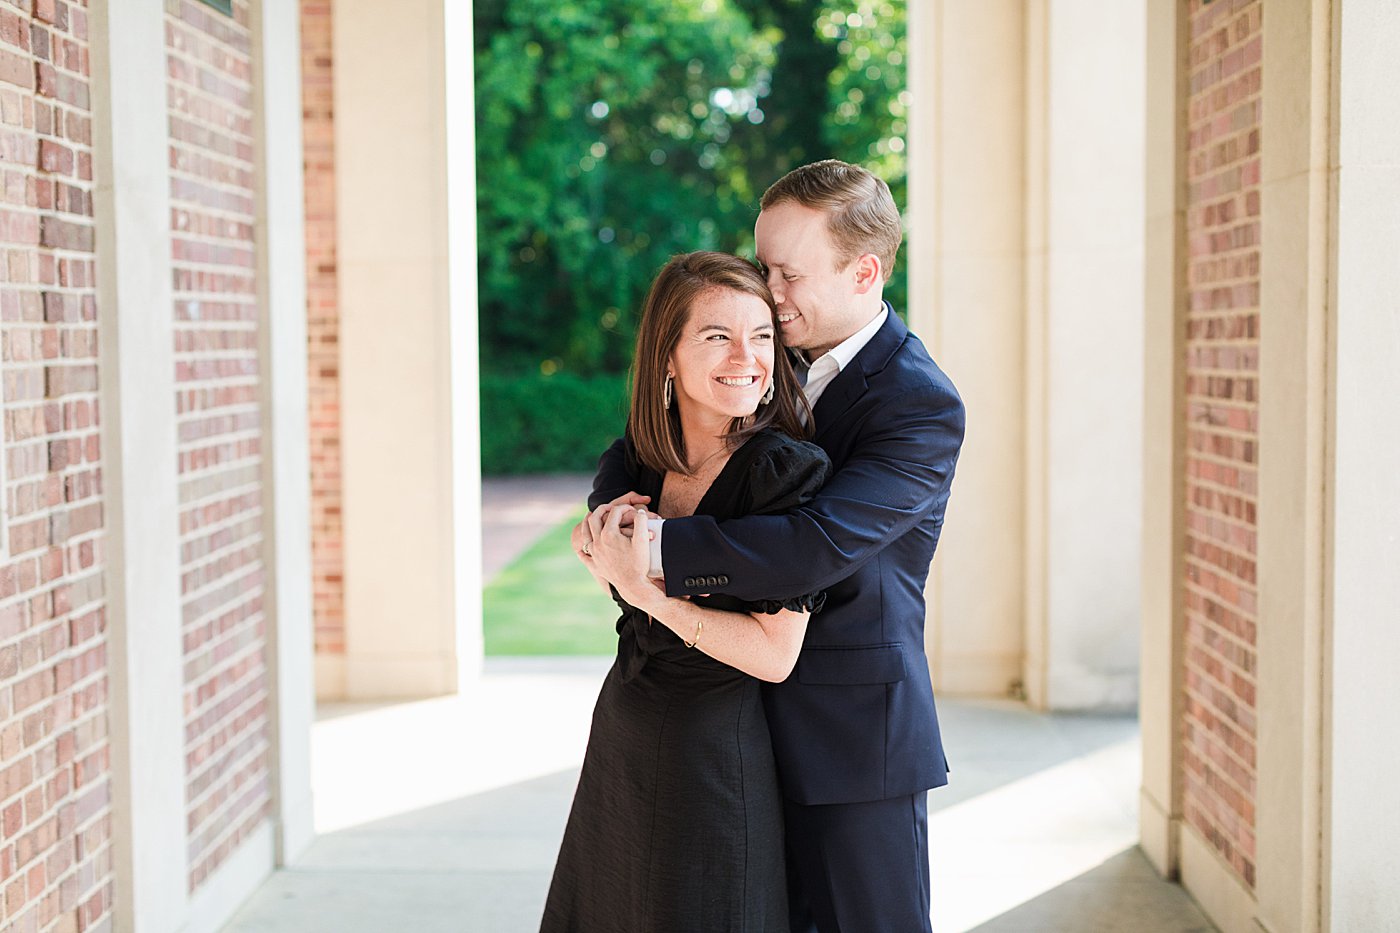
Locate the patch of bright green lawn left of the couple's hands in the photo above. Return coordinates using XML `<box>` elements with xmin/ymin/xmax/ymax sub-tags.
<box><xmin>482</xmin><ymin>510</ymin><xmax>619</xmax><ymax>654</ymax></box>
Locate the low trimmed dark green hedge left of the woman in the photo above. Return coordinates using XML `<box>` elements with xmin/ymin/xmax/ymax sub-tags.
<box><xmin>482</xmin><ymin>370</ymin><xmax>627</xmax><ymax>476</ymax></box>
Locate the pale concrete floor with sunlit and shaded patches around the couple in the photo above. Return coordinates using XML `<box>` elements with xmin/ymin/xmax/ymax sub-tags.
<box><xmin>225</xmin><ymin>658</ymin><xmax>1214</xmax><ymax>933</ymax></box>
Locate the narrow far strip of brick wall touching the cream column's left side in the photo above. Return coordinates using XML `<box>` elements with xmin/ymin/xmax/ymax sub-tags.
<box><xmin>301</xmin><ymin>0</ymin><xmax>344</xmax><ymax>654</ymax></box>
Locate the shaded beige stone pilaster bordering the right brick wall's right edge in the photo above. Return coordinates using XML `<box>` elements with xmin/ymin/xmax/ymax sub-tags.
<box><xmin>1248</xmin><ymin>0</ymin><xmax>1333</xmax><ymax>933</ymax></box>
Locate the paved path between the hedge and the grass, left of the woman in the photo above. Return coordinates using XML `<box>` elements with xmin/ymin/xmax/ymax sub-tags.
<box><xmin>482</xmin><ymin>474</ymin><xmax>592</xmax><ymax>580</ymax></box>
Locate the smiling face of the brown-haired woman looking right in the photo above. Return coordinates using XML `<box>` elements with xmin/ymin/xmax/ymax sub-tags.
<box><xmin>671</xmin><ymin>287</ymin><xmax>777</xmax><ymax>430</ymax></box>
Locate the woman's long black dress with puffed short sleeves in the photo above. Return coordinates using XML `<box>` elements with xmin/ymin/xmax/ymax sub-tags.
<box><xmin>540</xmin><ymin>431</ymin><xmax>830</xmax><ymax>933</ymax></box>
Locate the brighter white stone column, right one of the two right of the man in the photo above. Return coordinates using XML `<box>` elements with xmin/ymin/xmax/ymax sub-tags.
<box><xmin>1024</xmin><ymin>0</ymin><xmax>1147</xmax><ymax>709</ymax></box>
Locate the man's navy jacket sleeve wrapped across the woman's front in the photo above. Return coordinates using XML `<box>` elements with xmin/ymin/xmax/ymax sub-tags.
<box><xmin>661</xmin><ymin>385</ymin><xmax>963</xmax><ymax>600</ymax></box>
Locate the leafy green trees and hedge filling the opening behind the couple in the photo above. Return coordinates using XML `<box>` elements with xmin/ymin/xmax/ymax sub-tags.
<box><xmin>473</xmin><ymin>0</ymin><xmax>909</xmax><ymax>472</ymax></box>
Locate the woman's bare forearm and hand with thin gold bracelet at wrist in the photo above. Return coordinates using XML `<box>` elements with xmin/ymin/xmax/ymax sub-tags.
<box><xmin>588</xmin><ymin>506</ymin><xmax>808</xmax><ymax>684</ymax></box>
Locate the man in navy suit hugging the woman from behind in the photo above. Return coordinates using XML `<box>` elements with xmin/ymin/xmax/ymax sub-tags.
<box><xmin>574</xmin><ymin>161</ymin><xmax>963</xmax><ymax>933</ymax></box>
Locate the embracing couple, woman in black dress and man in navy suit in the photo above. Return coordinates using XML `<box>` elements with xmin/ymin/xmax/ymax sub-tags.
<box><xmin>540</xmin><ymin>161</ymin><xmax>963</xmax><ymax>933</ymax></box>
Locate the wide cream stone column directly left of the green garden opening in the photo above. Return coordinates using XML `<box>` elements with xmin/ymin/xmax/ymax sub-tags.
<box><xmin>333</xmin><ymin>0</ymin><xmax>480</xmax><ymax>698</ymax></box>
